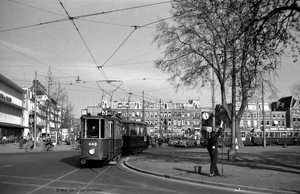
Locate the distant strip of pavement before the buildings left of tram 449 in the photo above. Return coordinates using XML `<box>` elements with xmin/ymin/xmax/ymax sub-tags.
<box><xmin>0</xmin><ymin>143</ymin><xmax>76</xmax><ymax>154</ymax></box>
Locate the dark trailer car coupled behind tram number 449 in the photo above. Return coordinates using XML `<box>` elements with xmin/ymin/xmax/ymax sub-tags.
<box><xmin>122</xmin><ymin>120</ymin><xmax>150</xmax><ymax>155</ymax></box>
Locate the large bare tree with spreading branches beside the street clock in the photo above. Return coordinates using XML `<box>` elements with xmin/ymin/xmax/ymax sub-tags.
<box><xmin>154</xmin><ymin>0</ymin><xmax>297</xmax><ymax>155</ymax></box>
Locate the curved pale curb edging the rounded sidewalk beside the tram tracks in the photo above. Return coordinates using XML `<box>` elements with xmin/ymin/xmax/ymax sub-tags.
<box><xmin>123</xmin><ymin>157</ymin><xmax>297</xmax><ymax>194</ymax></box>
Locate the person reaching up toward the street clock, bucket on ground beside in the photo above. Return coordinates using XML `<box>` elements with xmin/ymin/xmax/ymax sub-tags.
<box><xmin>207</xmin><ymin>127</ymin><xmax>223</xmax><ymax>177</ymax></box>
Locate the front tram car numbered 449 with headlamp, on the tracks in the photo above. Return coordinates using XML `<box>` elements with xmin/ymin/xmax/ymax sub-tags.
<box><xmin>79</xmin><ymin>106</ymin><xmax>123</xmax><ymax>165</ymax></box>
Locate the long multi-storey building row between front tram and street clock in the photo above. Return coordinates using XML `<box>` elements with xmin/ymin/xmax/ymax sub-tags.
<box><xmin>106</xmin><ymin>100</ymin><xmax>201</xmax><ymax>137</ymax></box>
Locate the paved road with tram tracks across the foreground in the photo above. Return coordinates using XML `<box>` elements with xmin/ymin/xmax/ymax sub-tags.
<box><xmin>0</xmin><ymin>150</ymin><xmax>260</xmax><ymax>194</ymax></box>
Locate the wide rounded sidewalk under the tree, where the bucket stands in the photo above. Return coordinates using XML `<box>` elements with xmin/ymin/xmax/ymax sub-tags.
<box><xmin>124</xmin><ymin>146</ymin><xmax>300</xmax><ymax>193</ymax></box>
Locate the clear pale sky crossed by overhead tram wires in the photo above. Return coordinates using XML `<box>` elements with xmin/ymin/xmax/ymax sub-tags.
<box><xmin>0</xmin><ymin>0</ymin><xmax>300</xmax><ymax>116</ymax></box>
